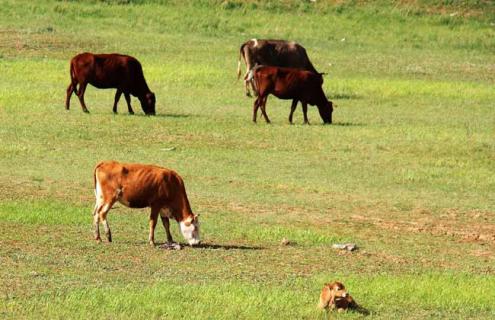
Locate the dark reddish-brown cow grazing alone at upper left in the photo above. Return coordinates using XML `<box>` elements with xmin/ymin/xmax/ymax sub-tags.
<box><xmin>65</xmin><ymin>52</ymin><xmax>156</xmax><ymax>115</ymax></box>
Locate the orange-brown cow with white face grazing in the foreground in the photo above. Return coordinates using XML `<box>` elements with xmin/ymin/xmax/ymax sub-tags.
<box><xmin>93</xmin><ymin>161</ymin><xmax>200</xmax><ymax>245</ymax></box>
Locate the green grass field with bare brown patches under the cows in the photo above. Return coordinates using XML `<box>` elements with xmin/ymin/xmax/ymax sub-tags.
<box><xmin>0</xmin><ymin>0</ymin><xmax>495</xmax><ymax>319</ymax></box>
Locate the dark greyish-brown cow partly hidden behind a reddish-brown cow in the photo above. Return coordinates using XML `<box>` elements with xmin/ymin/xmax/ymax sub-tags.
<box><xmin>237</xmin><ymin>39</ymin><xmax>318</xmax><ymax>96</ymax></box>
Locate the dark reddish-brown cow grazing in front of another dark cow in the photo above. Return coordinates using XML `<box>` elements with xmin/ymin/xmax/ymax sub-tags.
<box><xmin>248</xmin><ymin>66</ymin><xmax>333</xmax><ymax>124</ymax></box>
